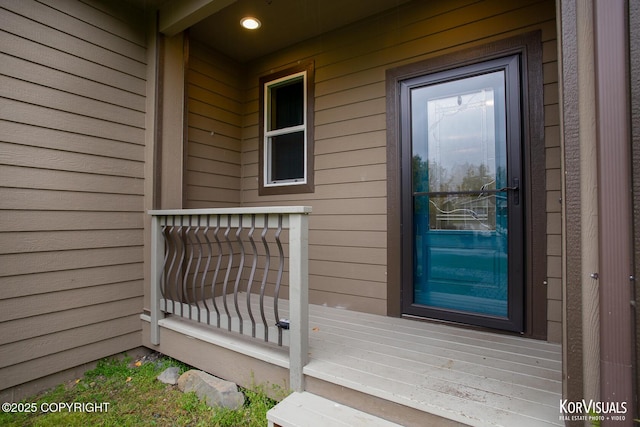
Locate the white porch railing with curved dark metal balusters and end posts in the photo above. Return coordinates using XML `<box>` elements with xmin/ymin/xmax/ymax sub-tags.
<box><xmin>149</xmin><ymin>206</ymin><xmax>311</xmax><ymax>391</ymax></box>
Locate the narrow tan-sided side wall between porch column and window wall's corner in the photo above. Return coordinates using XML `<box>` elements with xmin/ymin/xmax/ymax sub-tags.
<box><xmin>185</xmin><ymin>42</ymin><xmax>243</xmax><ymax>208</ymax></box>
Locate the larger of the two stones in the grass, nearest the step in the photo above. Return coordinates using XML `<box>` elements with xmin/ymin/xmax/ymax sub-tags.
<box><xmin>178</xmin><ymin>369</ymin><xmax>244</xmax><ymax>410</ymax></box>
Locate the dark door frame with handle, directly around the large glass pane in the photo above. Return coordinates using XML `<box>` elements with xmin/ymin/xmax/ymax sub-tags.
<box><xmin>400</xmin><ymin>55</ymin><xmax>526</xmax><ymax>332</ymax></box>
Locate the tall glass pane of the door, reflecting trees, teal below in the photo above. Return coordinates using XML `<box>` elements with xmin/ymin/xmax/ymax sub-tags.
<box><xmin>411</xmin><ymin>71</ymin><xmax>508</xmax><ymax>317</ymax></box>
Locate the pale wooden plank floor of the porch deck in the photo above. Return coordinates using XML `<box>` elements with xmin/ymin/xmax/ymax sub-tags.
<box><xmin>149</xmin><ymin>301</ymin><xmax>563</xmax><ymax>427</ymax></box>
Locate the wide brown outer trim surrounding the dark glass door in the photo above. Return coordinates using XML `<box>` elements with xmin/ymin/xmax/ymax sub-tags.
<box><xmin>386</xmin><ymin>31</ymin><xmax>547</xmax><ymax>339</ymax></box>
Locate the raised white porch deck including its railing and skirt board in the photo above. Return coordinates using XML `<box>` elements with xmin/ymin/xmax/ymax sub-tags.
<box><xmin>142</xmin><ymin>207</ymin><xmax>564</xmax><ymax>426</ymax></box>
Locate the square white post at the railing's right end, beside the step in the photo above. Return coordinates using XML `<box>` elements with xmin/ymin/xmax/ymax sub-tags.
<box><xmin>289</xmin><ymin>213</ymin><xmax>309</xmax><ymax>392</ymax></box>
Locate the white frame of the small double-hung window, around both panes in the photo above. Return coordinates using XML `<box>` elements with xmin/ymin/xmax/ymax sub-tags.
<box><xmin>262</xmin><ymin>70</ymin><xmax>309</xmax><ymax>187</ymax></box>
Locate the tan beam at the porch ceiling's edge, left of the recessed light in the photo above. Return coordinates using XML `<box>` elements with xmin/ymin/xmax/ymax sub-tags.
<box><xmin>158</xmin><ymin>0</ymin><xmax>236</xmax><ymax>37</ymax></box>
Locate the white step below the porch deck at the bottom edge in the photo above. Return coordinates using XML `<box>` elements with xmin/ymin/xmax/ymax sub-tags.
<box><xmin>267</xmin><ymin>391</ymin><xmax>400</xmax><ymax>427</ymax></box>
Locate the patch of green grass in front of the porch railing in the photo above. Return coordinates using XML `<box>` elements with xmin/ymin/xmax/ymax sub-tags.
<box><xmin>0</xmin><ymin>356</ymin><xmax>277</xmax><ymax>427</ymax></box>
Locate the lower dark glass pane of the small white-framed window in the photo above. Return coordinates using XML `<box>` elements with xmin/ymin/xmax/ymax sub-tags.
<box><xmin>269</xmin><ymin>131</ymin><xmax>304</xmax><ymax>182</ymax></box>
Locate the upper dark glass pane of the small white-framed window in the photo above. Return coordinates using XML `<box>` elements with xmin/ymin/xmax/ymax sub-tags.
<box><xmin>268</xmin><ymin>77</ymin><xmax>304</xmax><ymax>130</ymax></box>
